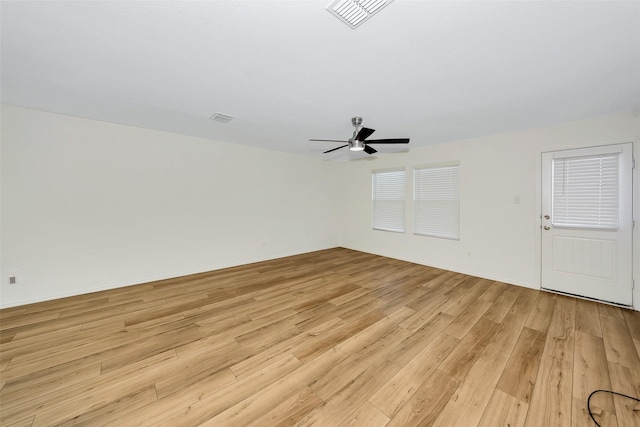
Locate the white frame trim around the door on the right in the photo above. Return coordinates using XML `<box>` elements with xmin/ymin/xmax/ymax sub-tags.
<box><xmin>535</xmin><ymin>138</ymin><xmax>640</xmax><ymax>311</ymax></box>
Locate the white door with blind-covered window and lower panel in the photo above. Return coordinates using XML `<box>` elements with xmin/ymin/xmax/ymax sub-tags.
<box><xmin>541</xmin><ymin>143</ymin><xmax>633</xmax><ymax>306</ymax></box>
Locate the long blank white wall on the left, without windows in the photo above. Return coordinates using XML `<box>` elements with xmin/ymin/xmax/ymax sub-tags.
<box><xmin>0</xmin><ymin>105</ymin><xmax>339</xmax><ymax>307</ymax></box>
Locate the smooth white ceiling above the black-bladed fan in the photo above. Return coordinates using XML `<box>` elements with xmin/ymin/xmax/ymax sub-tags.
<box><xmin>0</xmin><ymin>0</ymin><xmax>640</xmax><ymax>159</ymax></box>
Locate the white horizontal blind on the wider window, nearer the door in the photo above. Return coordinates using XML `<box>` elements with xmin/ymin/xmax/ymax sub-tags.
<box><xmin>413</xmin><ymin>165</ymin><xmax>460</xmax><ymax>239</ymax></box>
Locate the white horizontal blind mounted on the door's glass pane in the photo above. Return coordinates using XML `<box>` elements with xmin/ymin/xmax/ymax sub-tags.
<box><xmin>552</xmin><ymin>154</ymin><xmax>619</xmax><ymax>230</ymax></box>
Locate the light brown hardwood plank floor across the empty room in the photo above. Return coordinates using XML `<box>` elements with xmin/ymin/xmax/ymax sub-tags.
<box><xmin>0</xmin><ymin>248</ymin><xmax>640</xmax><ymax>427</ymax></box>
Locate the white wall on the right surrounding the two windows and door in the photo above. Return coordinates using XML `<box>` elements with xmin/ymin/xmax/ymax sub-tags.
<box><xmin>341</xmin><ymin>113</ymin><xmax>640</xmax><ymax>308</ymax></box>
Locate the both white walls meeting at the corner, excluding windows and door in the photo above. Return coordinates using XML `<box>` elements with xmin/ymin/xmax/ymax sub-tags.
<box><xmin>0</xmin><ymin>105</ymin><xmax>640</xmax><ymax>308</ymax></box>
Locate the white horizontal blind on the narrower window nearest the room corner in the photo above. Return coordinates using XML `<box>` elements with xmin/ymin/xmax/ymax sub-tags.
<box><xmin>371</xmin><ymin>169</ymin><xmax>406</xmax><ymax>233</ymax></box>
